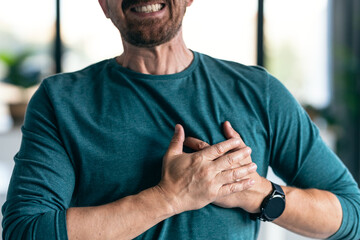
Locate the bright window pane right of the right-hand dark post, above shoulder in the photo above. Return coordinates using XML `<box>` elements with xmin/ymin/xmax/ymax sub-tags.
<box><xmin>264</xmin><ymin>0</ymin><xmax>330</xmax><ymax>108</ymax></box>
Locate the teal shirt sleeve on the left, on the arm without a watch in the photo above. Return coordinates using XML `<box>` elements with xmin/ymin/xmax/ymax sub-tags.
<box><xmin>2</xmin><ymin>83</ymin><xmax>75</xmax><ymax>240</ymax></box>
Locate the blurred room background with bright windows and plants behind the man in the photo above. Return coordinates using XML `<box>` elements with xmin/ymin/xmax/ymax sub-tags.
<box><xmin>0</xmin><ymin>0</ymin><xmax>360</xmax><ymax>240</ymax></box>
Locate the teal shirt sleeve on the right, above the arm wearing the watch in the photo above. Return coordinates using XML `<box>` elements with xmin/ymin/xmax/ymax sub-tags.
<box><xmin>268</xmin><ymin>75</ymin><xmax>360</xmax><ymax>239</ymax></box>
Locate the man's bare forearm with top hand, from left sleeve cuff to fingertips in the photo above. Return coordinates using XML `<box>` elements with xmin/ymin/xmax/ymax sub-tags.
<box><xmin>66</xmin><ymin>125</ymin><xmax>252</xmax><ymax>239</ymax></box>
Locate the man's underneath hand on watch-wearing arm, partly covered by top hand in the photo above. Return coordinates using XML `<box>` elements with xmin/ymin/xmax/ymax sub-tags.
<box><xmin>184</xmin><ymin>121</ymin><xmax>272</xmax><ymax>213</ymax></box>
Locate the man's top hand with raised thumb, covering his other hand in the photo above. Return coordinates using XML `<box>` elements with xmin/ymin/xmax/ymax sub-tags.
<box><xmin>155</xmin><ymin>124</ymin><xmax>255</xmax><ymax>214</ymax></box>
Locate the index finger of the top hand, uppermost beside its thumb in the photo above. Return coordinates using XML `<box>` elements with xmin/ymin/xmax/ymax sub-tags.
<box><xmin>197</xmin><ymin>138</ymin><xmax>241</xmax><ymax>161</ymax></box>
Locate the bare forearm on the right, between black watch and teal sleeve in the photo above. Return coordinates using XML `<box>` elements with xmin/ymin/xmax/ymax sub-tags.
<box><xmin>274</xmin><ymin>187</ymin><xmax>342</xmax><ymax>238</ymax></box>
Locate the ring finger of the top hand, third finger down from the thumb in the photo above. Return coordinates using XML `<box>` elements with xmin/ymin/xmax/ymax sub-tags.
<box><xmin>216</xmin><ymin>163</ymin><xmax>257</xmax><ymax>185</ymax></box>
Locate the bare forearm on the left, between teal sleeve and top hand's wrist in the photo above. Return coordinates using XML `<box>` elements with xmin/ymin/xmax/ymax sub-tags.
<box><xmin>66</xmin><ymin>188</ymin><xmax>174</xmax><ymax>240</ymax></box>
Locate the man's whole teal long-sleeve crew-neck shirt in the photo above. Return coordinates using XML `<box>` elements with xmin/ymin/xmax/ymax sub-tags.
<box><xmin>2</xmin><ymin>52</ymin><xmax>360</xmax><ymax>240</ymax></box>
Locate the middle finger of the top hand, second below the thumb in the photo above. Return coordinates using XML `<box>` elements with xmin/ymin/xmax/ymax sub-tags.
<box><xmin>214</xmin><ymin>147</ymin><xmax>251</xmax><ymax>172</ymax></box>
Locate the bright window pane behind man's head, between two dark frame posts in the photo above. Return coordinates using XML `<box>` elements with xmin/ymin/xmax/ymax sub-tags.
<box><xmin>61</xmin><ymin>0</ymin><xmax>257</xmax><ymax>71</ymax></box>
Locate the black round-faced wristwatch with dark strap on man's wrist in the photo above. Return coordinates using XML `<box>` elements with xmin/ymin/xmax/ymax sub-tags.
<box><xmin>250</xmin><ymin>182</ymin><xmax>286</xmax><ymax>222</ymax></box>
